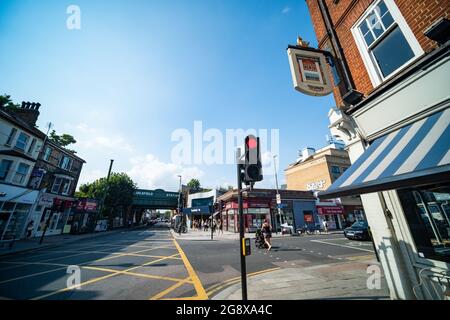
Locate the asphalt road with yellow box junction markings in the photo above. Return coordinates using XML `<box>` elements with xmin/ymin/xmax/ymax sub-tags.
<box><xmin>0</xmin><ymin>227</ymin><xmax>373</xmax><ymax>300</ymax></box>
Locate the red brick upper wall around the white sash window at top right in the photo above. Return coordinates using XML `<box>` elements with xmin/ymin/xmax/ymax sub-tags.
<box><xmin>306</xmin><ymin>0</ymin><xmax>450</xmax><ymax>106</ymax></box>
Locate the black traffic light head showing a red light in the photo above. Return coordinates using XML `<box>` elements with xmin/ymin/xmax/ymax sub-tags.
<box><xmin>243</xmin><ymin>135</ymin><xmax>263</xmax><ymax>185</ymax></box>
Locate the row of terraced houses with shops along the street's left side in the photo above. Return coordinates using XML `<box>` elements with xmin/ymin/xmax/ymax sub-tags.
<box><xmin>0</xmin><ymin>102</ymin><xmax>85</xmax><ymax>241</ymax></box>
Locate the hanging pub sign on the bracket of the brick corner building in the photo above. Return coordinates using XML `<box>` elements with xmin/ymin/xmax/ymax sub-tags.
<box><xmin>287</xmin><ymin>37</ymin><xmax>333</xmax><ymax>96</ymax></box>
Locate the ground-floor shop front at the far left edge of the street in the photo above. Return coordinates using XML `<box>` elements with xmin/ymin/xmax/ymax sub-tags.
<box><xmin>0</xmin><ymin>184</ymin><xmax>38</xmax><ymax>240</ymax></box>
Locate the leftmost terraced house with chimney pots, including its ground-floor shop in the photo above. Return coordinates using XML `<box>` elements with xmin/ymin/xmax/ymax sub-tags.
<box><xmin>0</xmin><ymin>103</ymin><xmax>45</xmax><ymax>240</ymax></box>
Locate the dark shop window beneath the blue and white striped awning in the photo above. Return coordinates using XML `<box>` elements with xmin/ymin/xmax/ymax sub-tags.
<box><xmin>398</xmin><ymin>184</ymin><xmax>450</xmax><ymax>262</ymax></box>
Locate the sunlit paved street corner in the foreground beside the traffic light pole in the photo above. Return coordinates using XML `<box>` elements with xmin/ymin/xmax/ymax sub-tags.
<box><xmin>210</xmin><ymin>262</ymin><xmax>389</xmax><ymax>300</ymax></box>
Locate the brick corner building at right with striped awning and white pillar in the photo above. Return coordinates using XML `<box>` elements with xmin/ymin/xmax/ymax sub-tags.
<box><xmin>306</xmin><ymin>0</ymin><xmax>450</xmax><ymax>299</ymax></box>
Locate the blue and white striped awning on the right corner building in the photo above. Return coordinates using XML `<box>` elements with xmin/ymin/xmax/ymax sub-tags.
<box><xmin>319</xmin><ymin>108</ymin><xmax>450</xmax><ymax>199</ymax></box>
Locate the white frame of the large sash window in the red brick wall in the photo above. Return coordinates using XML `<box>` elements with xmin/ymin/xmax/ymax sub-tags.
<box><xmin>351</xmin><ymin>0</ymin><xmax>424</xmax><ymax>87</ymax></box>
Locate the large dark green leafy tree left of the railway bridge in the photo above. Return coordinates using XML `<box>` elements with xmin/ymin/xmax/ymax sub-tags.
<box><xmin>76</xmin><ymin>173</ymin><xmax>136</xmax><ymax>225</ymax></box>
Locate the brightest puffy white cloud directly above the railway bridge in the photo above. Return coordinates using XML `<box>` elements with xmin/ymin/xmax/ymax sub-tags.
<box><xmin>127</xmin><ymin>154</ymin><xmax>204</xmax><ymax>191</ymax></box>
